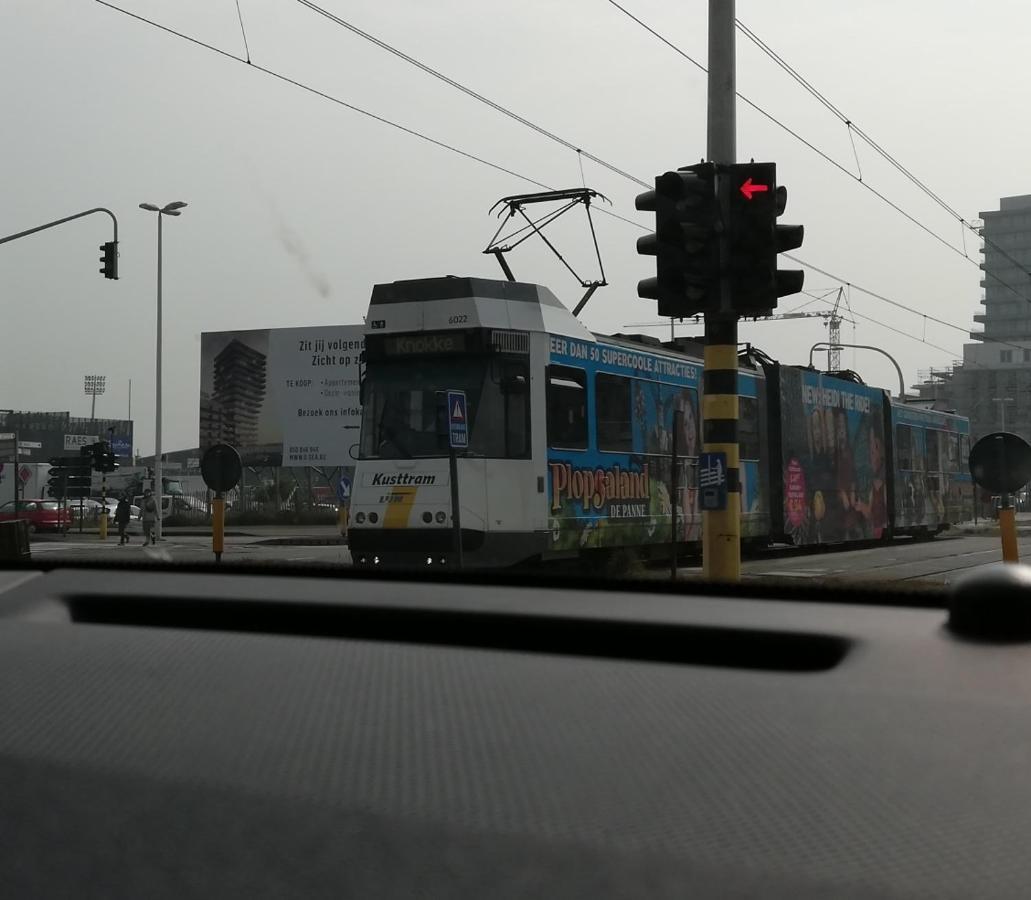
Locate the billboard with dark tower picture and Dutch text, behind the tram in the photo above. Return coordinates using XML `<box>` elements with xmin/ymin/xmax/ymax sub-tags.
<box><xmin>200</xmin><ymin>325</ymin><xmax>365</xmax><ymax>466</ymax></box>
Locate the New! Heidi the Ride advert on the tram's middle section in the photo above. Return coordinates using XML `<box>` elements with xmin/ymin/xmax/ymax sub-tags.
<box><xmin>780</xmin><ymin>366</ymin><xmax>888</xmax><ymax>544</ymax></box>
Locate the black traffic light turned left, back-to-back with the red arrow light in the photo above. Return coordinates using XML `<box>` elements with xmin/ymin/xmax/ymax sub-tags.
<box><xmin>635</xmin><ymin>163</ymin><xmax>720</xmax><ymax>319</ymax></box>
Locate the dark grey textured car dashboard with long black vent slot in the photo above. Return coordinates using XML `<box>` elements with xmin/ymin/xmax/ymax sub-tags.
<box><xmin>0</xmin><ymin>566</ymin><xmax>1031</xmax><ymax>900</ymax></box>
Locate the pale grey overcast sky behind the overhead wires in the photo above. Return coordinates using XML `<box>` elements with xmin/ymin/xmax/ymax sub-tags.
<box><xmin>0</xmin><ymin>0</ymin><xmax>1031</xmax><ymax>453</ymax></box>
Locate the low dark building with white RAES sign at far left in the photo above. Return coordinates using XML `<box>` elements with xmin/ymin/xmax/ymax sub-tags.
<box><xmin>0</xmin><ymin>409</ymin><xmax>134</xmax><ymax>465</ymax></box>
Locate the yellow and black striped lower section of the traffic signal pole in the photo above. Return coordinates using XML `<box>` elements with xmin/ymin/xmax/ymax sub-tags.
<box><xmin>702</xmin><ymin>311</ymin><xmax>741</xmax><ymax>581</ymax></box>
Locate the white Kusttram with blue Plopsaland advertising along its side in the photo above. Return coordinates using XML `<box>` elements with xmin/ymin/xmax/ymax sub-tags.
<box><xmin>348</xmin><ymin>276</ymin><xmax>973</xmax><ymax>567</ymax></box>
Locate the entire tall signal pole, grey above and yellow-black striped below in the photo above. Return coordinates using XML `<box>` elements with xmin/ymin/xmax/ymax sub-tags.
<box><xmin>702</xmin><ymin>0</ymin><xmax>741</xmax><ymax>581</ymax></box>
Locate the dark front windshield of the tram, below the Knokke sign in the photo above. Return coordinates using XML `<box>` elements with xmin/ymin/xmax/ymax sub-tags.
<box><xmin>361</xmin><ymin>356</ymin><xmax>530</xmax><ymax>460</ymax></box>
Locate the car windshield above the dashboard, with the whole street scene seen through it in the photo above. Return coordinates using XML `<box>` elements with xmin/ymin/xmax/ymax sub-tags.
<box><xmin>0</xmin><ymin>0</ymin><xmax>1018</xmax><ymax>597</ymax></box>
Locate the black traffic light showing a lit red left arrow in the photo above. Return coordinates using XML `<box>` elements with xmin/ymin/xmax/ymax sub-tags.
<box><xmin>720</xmin><ymin>163</ymin><xmax>804</xmax><ymax>315</ymax></box>
